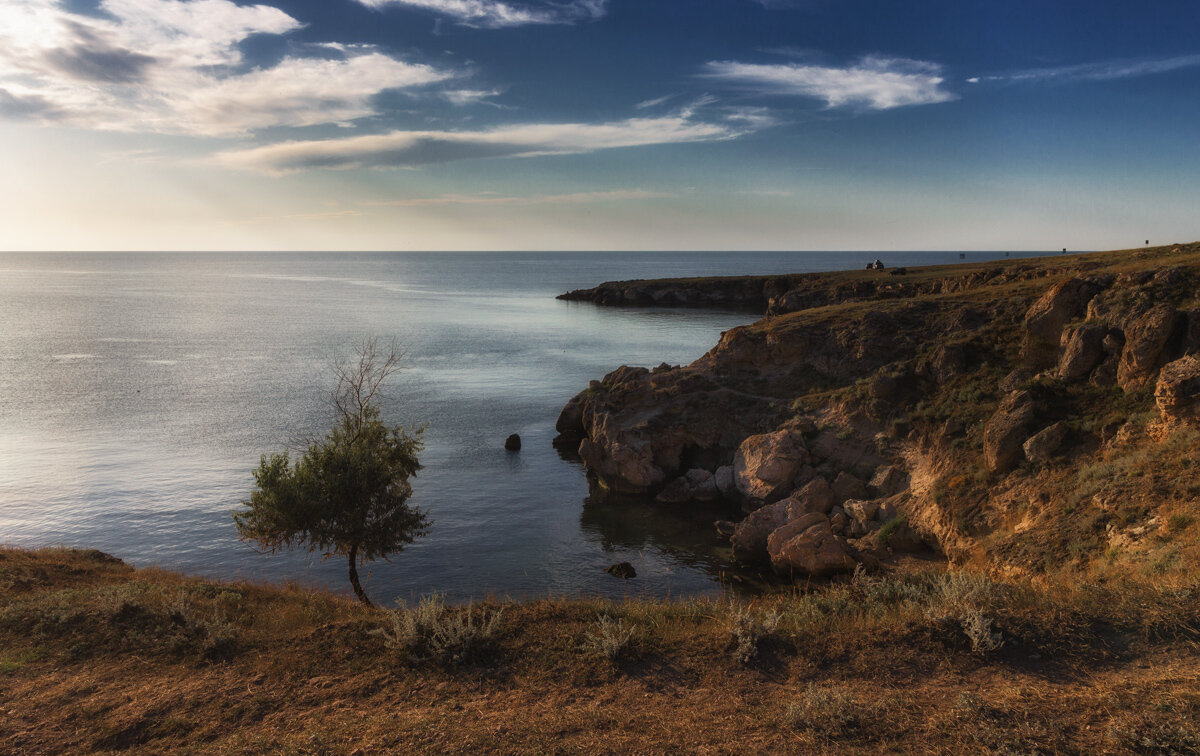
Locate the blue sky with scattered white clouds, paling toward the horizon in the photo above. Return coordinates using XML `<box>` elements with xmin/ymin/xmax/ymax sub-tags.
<box><xmin>0</xmin><ymin>0</ymin><xmax>1200</xmax><ymax>251</ymax></box>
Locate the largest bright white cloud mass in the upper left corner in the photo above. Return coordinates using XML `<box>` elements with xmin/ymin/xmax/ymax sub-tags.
<box><xmin>0</xmin><ymin>0</ymin><xmax>454</xmax><ymax>137</ymax></box>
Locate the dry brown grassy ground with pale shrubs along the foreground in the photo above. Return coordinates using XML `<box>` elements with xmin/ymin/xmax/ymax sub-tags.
<box><xmin>0</xmin><ymin>550</ymin><xmax>1200</xmax><ymax>754</ymax></box>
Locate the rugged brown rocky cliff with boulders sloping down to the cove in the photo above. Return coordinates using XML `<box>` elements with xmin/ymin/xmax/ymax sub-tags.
<box><xmin>558</xmin><ymin>244</ymin><xmax>1200</xmax><ymax>577</ymax></box>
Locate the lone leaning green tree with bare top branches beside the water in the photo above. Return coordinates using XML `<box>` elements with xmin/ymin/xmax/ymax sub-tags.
<box><xmin>233</xmin><ymin>338</ymin><xmax>430</xmax><ymax>606</ymax></box>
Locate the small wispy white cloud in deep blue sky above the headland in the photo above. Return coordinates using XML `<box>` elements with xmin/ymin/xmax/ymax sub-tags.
<box><xmin>704</xmin><ymin>56</ymin><xmax>954</xmax><ymax>110</ymax></box>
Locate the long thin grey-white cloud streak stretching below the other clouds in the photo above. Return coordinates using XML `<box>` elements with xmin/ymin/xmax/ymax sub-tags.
<box><xmin>215</xmin><ymin>110</ymin><xmax>757</xmax><ymax>174</ymax></box>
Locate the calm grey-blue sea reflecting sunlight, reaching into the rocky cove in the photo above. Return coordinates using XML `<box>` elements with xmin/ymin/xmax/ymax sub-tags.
<box><xmin>0</xmin><ymin>253</ymin><xmax>1051</xmax><ymax>601</ymax></box>
